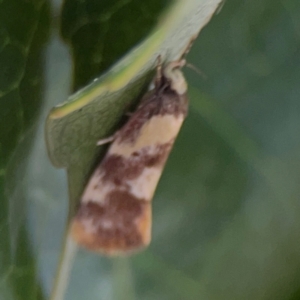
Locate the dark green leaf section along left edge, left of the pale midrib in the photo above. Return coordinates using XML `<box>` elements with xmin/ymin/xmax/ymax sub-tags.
<box><xmin>0</xmin><ymin>0</ymin><xmax>49</xmax><ymax>299</ymax></box>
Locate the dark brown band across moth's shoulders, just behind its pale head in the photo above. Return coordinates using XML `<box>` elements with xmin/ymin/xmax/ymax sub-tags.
<box><xmin>116</xmin><ymin>85</ymin><xmax>188</xmax><ymax>143</ymax></box>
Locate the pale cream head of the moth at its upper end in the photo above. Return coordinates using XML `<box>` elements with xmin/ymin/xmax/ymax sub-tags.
<box><xmin>164</xmin><ymin>60</ymin><xmax>187</xmax><ymax>95</ymax></box>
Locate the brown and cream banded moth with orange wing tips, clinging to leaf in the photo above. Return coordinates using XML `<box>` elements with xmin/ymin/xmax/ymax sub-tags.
<box><xmin>70</xmin><ymin>59</ymin><xmax>188</xmax><ymax>255</ymax></box>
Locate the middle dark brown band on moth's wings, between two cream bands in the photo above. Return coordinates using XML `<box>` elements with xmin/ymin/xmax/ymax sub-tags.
<box><xmin>101</xmin><ymin>140</ymin><xmax>174</xmax><ymax>185</ymax></box>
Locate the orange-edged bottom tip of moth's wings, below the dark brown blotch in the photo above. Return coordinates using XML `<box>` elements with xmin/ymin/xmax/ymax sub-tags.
<box><xmin>70</xmin><ymin>204</ymin><xmax>152</xmax><ymax>256</ymax></box>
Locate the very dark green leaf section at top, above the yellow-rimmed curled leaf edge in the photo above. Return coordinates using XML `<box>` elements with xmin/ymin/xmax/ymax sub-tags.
<box><xmin>61</xmin><ymin>0</ymin><xmax>171</xmax><ymax>90</ymax></box>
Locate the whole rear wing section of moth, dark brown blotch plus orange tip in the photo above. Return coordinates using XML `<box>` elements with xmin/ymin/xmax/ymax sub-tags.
<box><xmin>71</xmin><ymin>190</ymin><xmax>151</xmax><ymax>254</ymax></box>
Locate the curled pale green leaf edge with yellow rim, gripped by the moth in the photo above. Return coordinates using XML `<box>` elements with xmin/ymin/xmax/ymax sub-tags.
<box><xmin>46</xmin><ymin>0</ymin><xmax>219</xmax><ymax>218</ymax></box>
